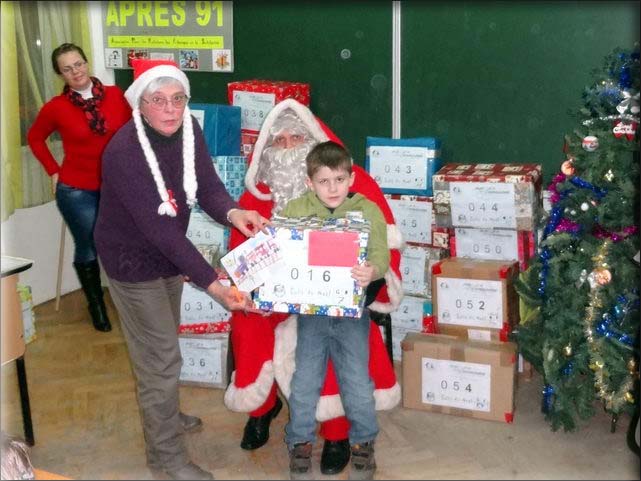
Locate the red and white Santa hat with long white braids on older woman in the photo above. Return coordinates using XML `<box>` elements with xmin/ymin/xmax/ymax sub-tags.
<box><xmin>125</xmin><ymin>58</ymin><xmax>198</xmax><ymax>217</ymax></box>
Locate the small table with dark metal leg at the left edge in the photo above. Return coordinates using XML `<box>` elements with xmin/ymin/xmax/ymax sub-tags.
<box><xmin>0</xmin><ymin>255</ymin><xmax>35</xmax><ymax>446</ymax></box>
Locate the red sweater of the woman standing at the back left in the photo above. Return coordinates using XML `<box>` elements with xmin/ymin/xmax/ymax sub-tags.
<box><xmin>27</xmin><ymin>85</ymin><xmax>131</xmax><ymax>190</ymax></box>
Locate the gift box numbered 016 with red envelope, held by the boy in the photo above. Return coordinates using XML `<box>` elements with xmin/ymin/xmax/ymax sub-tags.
<box><xmin>254</xmin><ymin>216</ymin><xmax>369</xmax><ymax>317</ymax></box>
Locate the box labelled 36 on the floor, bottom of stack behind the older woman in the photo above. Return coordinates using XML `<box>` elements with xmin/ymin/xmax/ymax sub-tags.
<box><xmin>178</xmin><ymin>333</ymin><xmax>229</xmax><ymax>389</ymax></box>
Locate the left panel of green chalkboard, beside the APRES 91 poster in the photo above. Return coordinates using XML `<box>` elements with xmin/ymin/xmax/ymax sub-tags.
<box><xmin>116</xmin><ymin>2</ymin><xmax>392</xmax><ymax>165</ymax></box>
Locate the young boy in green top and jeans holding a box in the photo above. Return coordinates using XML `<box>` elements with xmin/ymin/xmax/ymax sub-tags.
<box><xmin>280</xmin><ymin>141</ymin><xmax>390</xmax><ymax>479</ymax></box>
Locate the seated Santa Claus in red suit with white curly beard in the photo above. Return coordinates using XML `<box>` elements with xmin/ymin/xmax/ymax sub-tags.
<box><xmin>225</xmin><ymin>99</ymin><xmax>402</xmax><ymax>474</ymax></box>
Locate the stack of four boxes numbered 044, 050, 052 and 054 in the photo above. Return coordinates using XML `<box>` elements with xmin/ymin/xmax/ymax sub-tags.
<box><xmin>402</xmin><ymin>164</ymin><xmax>541</xmax><ymax>422</ymax></box>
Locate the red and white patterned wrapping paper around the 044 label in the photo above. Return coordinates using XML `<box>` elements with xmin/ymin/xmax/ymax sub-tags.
<box><xmin>432</xmin><ymin>163</ymin><xmax>542</xmax><ymax>231</ymax></box>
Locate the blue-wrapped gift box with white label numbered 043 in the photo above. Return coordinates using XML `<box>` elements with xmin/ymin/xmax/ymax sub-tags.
<box><xmin>365</xmin><ymin>137</ymin><xmax>442</xmax><ymax>197</ymax></box>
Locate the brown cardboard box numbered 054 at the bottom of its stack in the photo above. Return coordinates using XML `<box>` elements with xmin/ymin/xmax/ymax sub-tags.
<box><xmin>401</xmin><ymin>333</ymin><xmax>517</xmax><ymax>423</ymax></box>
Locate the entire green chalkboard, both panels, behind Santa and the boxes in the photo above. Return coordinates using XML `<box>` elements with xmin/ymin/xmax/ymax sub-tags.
<box><xmin>116</xmin><ymin>1</ymin><xmax>639</xmax><ymax>181</ymax></box>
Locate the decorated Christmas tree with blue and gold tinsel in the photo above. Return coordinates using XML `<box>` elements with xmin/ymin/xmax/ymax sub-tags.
<box><xmin>514</xmin><ymin>45</ymin><xmax>640</xmax><ymax>431</ymax></box>
